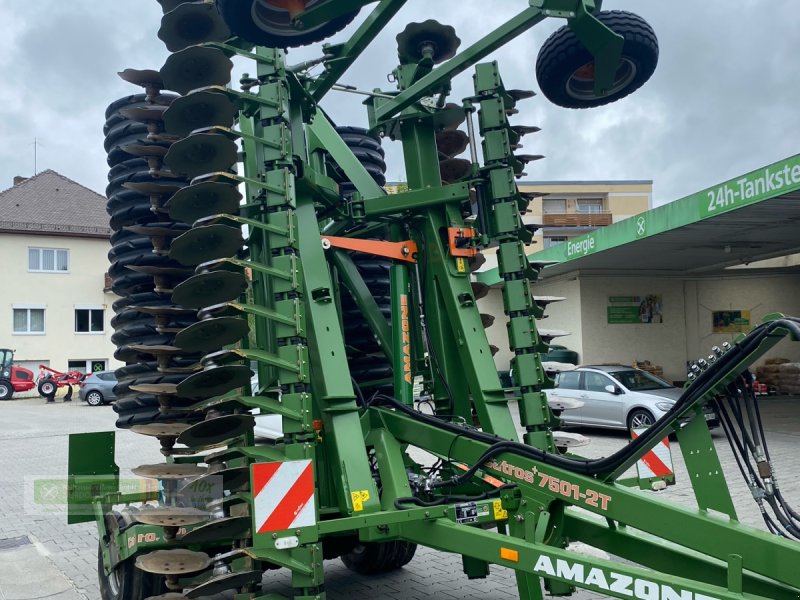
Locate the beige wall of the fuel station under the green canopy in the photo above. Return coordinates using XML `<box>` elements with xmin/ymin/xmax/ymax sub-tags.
<box><xmin>500</xmin><ymin>275</ymin><xmax>800</xmax><ymax>380</ymax></box>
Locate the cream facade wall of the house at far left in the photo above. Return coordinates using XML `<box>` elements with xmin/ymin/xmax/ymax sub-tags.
<box><xmin>0</xmin><ymin>234</ymin><xmax>122</xmax><ymax>370</ymax></box>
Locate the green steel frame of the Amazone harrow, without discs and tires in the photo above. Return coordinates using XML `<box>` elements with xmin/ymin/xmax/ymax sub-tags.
<box><xmin>70</xmin><ymin>0</ymin><xmax>800</xmax><ymax>600</ymax></box>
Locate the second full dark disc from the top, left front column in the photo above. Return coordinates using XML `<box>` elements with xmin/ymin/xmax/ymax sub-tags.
<box><xmin>161</xmin><ymin>46</ymin><xmax>233</xmax><ymax>96</ymax></box>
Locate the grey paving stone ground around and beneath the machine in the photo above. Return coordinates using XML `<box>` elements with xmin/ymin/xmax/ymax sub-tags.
<box><xmin>0</xmin><ymin>397</ymin><xmax>800</xmax><ymax>600</ymax></box>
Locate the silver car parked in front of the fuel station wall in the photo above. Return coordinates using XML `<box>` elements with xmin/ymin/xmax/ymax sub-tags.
<box><xmin>547</xmin><ymin>365</ymin><xmax>719</xmax><ymax>429</ymax></box>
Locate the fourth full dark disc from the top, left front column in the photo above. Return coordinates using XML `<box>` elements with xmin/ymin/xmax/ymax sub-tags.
<box><xmin>164</xmin><ymin>133</ymin><xmax>239</xmax><ymax>178</ymax></box>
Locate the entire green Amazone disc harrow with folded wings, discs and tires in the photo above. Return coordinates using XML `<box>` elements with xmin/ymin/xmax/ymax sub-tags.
<box><xmin>65</xmin><ymin>0</ymin><xmax>800</xmax><ymax>600</ymax></box>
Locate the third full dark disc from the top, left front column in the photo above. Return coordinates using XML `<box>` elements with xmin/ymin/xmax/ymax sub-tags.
<box><xmin>164</xmin><ymin>88</ymin><xmax>239</xmax><ymax>136</ymax></box>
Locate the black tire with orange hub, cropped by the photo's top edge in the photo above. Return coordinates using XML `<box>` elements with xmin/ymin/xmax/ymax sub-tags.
<box><xmin>217</xmin><ymin>0</ymin><xmax>358</xmax><ymax>48</ymax></box>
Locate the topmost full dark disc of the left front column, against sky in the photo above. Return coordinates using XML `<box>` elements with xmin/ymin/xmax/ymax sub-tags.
<box><xmin>158</xmin><ymin>2</ymin><xmax>231</xmax><ymax>52</ymax></box>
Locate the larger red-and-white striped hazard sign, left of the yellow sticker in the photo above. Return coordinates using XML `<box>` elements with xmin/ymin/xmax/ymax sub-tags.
<box><xmin>252</xmin><ymin>460</ymin><xmax>317</xmax><ymax>533</ymax></box>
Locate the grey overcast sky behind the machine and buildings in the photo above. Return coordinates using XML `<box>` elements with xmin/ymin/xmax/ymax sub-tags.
<box><xmin>0</xmin><ymin>0</ymin><xmax>800</xmax><ymax>205</ymax></box>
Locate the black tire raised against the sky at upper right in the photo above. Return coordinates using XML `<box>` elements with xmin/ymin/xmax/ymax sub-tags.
<box><xmin>536</xmin><ymin>10</ymin><xmax>658</xmax><ymax>108</ymax></box>
